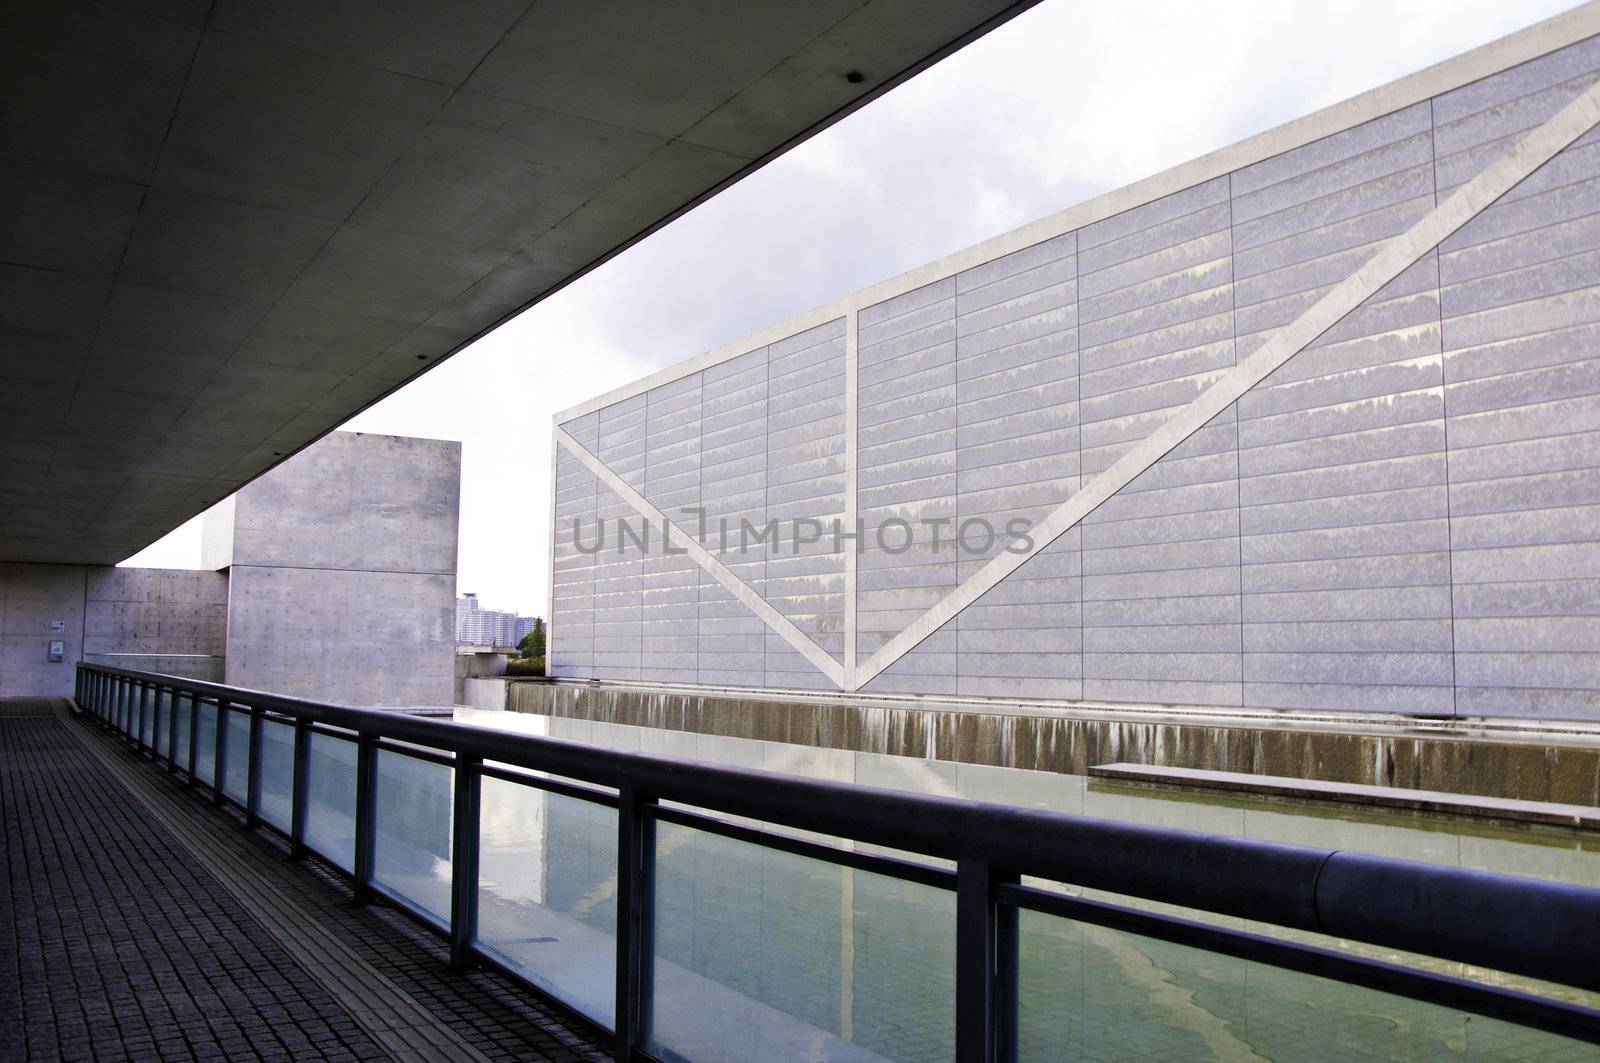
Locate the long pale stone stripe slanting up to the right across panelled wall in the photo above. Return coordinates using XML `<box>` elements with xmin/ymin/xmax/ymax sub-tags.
<box><xmin>846</xmin><ymin>72</ymin><xmax>1600</xmax><ymax>690</ymax></box>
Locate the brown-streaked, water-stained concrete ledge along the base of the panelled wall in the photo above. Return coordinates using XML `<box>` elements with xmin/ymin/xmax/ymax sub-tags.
<box><xmin>506</xmin><ymin>680</ymin><xmax>1600</xmax><ymax>807</ymax></box>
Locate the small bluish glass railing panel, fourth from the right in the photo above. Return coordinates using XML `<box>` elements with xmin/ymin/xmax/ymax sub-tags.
<box><xmin>373</xmin><ymin>749</ymin><xmax>454</xmax><ymax>927</ymax></box>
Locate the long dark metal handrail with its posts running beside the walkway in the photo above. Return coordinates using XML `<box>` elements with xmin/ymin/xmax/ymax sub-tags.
<box><xmin>78</xmin><ymin>664</ymin><xmax>1600</xmax><ymax>1060</ymax></box>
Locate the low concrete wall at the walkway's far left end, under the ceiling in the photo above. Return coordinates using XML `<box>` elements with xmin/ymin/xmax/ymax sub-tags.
<box><xmin>0</xmin><ymin>562</ymin><xmax>227</xmax><ymax>696</ymax></box>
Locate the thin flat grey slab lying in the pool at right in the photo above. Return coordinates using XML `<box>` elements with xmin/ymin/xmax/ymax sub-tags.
<box><xmin>1090</xmin><ymin>764</ymin><xmax>1600</xmax><ymax>831</ymax></box>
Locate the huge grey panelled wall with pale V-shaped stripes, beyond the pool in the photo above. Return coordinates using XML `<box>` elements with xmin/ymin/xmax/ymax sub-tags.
<box><xmin>550</xmin><ymin>18</ymin><xmax>1600</xmax><ymax>719</ymax></box>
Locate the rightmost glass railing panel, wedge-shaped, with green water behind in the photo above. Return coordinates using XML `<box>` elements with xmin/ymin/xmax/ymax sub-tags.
<box><xmin>1018</xmin><ymin>911</ymin><xmax>1594</xmax><ymax>1063</ymax></box>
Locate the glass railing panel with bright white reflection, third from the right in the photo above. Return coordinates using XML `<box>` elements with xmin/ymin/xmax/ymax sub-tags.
<box><xmin>477</xmin><ymin>778</ymin><xmax>616</xmax><ymax>1026</ymax></box>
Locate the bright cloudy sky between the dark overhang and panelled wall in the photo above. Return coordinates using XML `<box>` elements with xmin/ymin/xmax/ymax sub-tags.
<box><xmin>126</xmin><ymin>0</ymin><xmax>1574</xmax><ymax>613</ymax></box>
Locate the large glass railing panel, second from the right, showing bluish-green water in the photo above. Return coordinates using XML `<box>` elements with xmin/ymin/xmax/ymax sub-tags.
<box><xmin>646</xmin><ymin>823</ymin><xmax>955</xmax><ymax>1063</ymax></box>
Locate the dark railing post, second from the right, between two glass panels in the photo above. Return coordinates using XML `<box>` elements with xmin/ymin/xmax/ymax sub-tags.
<box><xmin>614</xmin><ymin>786</ymin><xmax>656</xmax><ymax>1063</ymax></box>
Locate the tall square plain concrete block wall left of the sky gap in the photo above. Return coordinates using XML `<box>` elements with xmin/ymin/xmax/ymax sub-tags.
<box><xmin>208</xmin><ymin>432</ymin><xmax>461</xmax><ymax>706</ymax></box>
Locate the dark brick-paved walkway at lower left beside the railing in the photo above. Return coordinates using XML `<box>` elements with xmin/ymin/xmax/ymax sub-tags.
<box><xmin>0</xmin><ymin>700</ymin><xmax>606</xmax><ymax>1063</ymax></box>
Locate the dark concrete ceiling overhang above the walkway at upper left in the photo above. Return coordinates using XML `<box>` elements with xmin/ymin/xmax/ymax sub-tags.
<box><xmin>0</xmin><ymin>0</ymin><xmax>1030</xmax><ymax>564</ymax></box>
